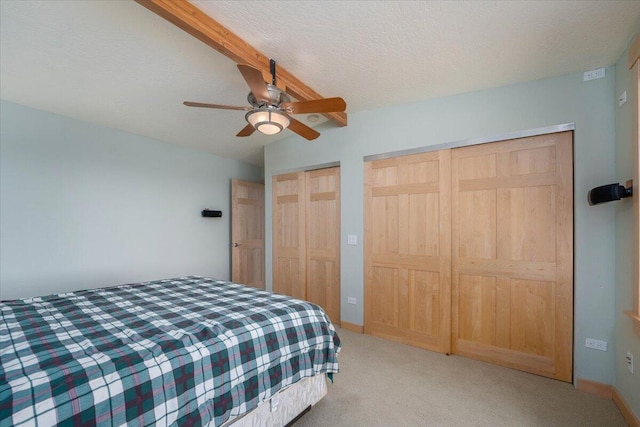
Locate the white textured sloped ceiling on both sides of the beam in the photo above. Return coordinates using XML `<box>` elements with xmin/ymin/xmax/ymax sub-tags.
<box><xmin>0</xmin><ymin>0</ymin><xmax>640</xmax><ymax>165</ymax></box>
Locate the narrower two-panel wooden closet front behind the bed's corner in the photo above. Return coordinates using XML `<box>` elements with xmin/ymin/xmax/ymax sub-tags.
<box><xmin>272</xmin><ymin>167</ymin><xmax>340</xmax><ymax>324</ymax></box>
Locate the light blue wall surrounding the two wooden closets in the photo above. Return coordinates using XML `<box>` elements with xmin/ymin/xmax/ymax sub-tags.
<box><xmin>265</xmin><ymin>68</ymin><xmax>615</xmax><ymax>384</ymax></box>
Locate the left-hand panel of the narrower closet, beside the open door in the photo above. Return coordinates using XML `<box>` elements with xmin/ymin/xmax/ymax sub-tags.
<box><xmin>271</xmin><ymin>172</ymin><xmax>306</xmax><ymax>299</ymax></box>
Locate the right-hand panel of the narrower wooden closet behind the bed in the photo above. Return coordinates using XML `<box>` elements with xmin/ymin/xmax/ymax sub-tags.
<box><xmin>306</xmin><ymin>167</ymin><xmax>340</xmax><ymax>324</ymax></box>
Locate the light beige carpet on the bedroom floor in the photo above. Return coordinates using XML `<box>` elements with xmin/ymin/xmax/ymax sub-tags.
<box><xmin>296</xmin><ymin>329</ymin><xmax>626</xmax><ymax>427</ymax></box>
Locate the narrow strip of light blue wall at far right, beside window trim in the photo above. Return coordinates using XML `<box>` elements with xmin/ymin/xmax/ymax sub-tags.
<box><xmin>612</xmin><ymin>41</ymin><xmax>640</xmax><ymax>417</ymax></box>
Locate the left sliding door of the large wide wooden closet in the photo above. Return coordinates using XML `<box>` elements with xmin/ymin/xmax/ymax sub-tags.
<box><xmin>364</xmin><ymin>150</ymin><xmax>451</xmax><ymax>353</ymax></box>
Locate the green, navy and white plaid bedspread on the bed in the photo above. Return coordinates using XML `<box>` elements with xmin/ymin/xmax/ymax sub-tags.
<box><xmin>0</xmin><ymin>277</ymin><xmax>340</xmax><ymax>426</ymax></box>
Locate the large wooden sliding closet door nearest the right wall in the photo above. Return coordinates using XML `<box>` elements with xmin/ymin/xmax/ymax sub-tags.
<box><xmin>452</xmin><ymin>132</ymin><xmax>573</xmax><ymax>381</ymax></box>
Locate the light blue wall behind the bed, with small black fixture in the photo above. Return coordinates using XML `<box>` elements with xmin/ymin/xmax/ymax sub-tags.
<box><xmin>0</xmin><ymin>101</ymin><xmax>262</xmax><ymax>299</ymax></box>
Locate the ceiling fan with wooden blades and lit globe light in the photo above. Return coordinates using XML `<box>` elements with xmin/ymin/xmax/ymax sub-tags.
<box><xmin>184</xmin><ymin>59</ymin><xmax>347</xmax><ymax>140</ymax></box>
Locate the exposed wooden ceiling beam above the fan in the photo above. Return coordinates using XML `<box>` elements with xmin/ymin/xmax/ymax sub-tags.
<box><xmin>135</xmin><ymin>0</ymin><xmax>347</xmax><ymax>126</ymax></box>
